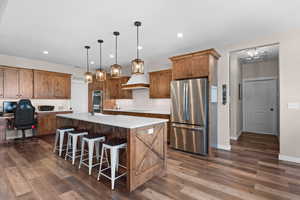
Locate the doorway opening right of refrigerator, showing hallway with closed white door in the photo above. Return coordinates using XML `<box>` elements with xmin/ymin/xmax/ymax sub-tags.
<box><xmin>229</xmin><ymin>44</ymin><xmax>280</xmax><ymax>152</ymax></box>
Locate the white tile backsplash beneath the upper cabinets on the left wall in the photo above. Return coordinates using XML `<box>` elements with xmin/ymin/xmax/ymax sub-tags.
<box><xmin>0</xmin><ymin>99</ymin><xmax>71</xmax><ymax>112</ymax></box>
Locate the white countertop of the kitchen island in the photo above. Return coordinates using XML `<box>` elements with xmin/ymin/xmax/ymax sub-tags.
<box><xmin>56</xmin><ymin>113</ymin><xmax>169</xmax><ymax>129</ymax></box>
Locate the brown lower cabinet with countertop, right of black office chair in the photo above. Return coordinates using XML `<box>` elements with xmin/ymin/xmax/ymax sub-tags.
<box><xmin>37</xmin><ymin>112</ymin><xmax>72</xmax><ymax>136</ymax></box>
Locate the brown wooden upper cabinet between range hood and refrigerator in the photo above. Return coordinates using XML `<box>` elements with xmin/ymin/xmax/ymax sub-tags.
<box><xmin>149</xmin><ymin>69</ymin><xmax>172</xmax><ymax>98</ymax></box>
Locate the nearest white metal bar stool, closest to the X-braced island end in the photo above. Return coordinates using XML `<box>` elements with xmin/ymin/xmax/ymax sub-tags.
<box><xmin>97</xmin><ymin>138</ymin><xmax>127</xmax><ymax>190</ymax></box>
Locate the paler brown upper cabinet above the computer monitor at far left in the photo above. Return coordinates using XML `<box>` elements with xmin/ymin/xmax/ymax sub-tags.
<box><xmin>0</xmin><ymin>67</ymin><xmax>33</xmax><ymax>99</ymax></box>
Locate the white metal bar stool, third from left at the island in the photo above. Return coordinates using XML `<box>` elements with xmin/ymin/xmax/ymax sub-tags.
<box><xmin>79</xmin><ymin>134</ymin><xmax>108</xmax><ymax>175</ymax></box>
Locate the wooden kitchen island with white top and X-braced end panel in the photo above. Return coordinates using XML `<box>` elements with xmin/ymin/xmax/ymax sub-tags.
<box><xmin>56</xmin><ymin>113</ymin><xmax>168</xmax><ymax>192</ymax></box>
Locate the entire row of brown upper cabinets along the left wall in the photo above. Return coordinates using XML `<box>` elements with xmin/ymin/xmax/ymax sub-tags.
<box><xmin>0</xmin><ymin>66</ymin><xmax>71</xmax><ymax>99</ymax></box>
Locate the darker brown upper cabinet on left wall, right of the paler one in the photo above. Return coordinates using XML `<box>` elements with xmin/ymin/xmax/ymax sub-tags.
<box><xmin>33</xmin><ymin>70</ymin><xmax>71</xmax><ymax>99</ymax></box>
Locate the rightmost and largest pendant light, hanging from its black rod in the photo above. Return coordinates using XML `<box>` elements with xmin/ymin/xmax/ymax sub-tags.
<box><xmin>131</xmin><ymin>21</ymin><xmax>144</xmax><ymax>74</ymax></box>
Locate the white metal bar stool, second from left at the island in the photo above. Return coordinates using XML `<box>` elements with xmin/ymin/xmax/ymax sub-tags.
<box><xmin>65</xmin><ymin>130</ymin><xmax>88</xmax><ymax>165</ymax></box>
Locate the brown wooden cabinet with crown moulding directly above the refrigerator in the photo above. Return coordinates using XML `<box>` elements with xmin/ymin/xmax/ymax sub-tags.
<box><xmin>170</xmin><ymin>49</ymin><xmax>220</xmax><ymax>80</ymax></box>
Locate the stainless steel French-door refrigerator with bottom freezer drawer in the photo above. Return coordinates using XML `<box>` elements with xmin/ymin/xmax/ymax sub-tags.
<box><xmin>170</xmin><ymin>78</ymin><xmax>208</xmax><ymax>155</ymax></box>
